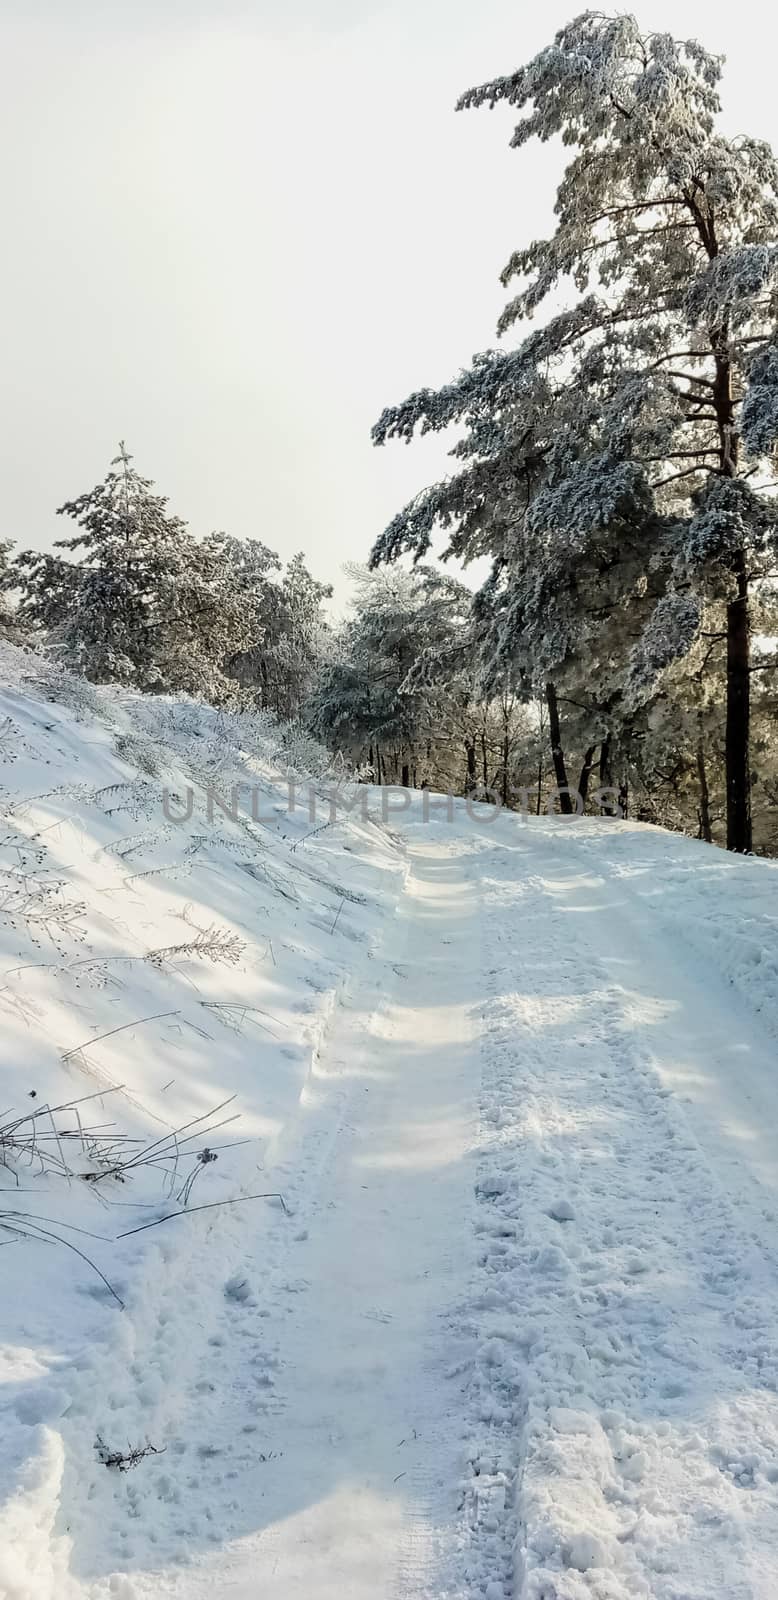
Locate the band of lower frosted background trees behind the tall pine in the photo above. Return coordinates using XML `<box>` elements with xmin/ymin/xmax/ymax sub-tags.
<box><xmin>2</xmin><ymin>432</ymin><xmax>778</xmax><ymax>853</ymax></box>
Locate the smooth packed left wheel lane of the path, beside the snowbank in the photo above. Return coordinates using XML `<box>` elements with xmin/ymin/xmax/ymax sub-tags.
<box><xmin>72</xmin><ymin>840</ymin><xmax>479</xmax><ymax>1600</ymax></box>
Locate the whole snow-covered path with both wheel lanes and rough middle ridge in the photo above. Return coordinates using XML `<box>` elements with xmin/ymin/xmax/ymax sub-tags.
<box><xmin>30</xmin><ymin>818</ymin><xmax>778</xmax><ymax>1600</ymax></box>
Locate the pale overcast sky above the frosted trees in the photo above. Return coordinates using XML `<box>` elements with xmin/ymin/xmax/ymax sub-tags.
<box><xmin>0</xmin><ymin>0</ymin><xmax>778</xmax><ymax>611</ymax></box>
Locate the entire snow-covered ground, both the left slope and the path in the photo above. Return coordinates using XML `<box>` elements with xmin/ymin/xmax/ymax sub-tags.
<box><xmin>0</xmin><ymin>651</ymin><xmax>778</xmax><ymax>1600</ymax></box>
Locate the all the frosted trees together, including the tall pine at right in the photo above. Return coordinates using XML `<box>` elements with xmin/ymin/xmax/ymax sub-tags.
<box><xmin>2</xmin><ymin>13</ymin><xmax>778</xmax><ymax>853</ymax></box>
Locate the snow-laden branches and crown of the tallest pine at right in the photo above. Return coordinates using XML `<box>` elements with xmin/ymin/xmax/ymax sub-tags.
<box><xmin>373</xmin><ymin>13</ymin><xmax>778</xmax><ymax>851</ymax></box>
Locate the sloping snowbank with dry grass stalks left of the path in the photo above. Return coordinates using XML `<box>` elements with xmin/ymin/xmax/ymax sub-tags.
<box><xmin>0</xmin><ymin>646</ymin><xmax>405</xmax><ymax>1600</ymax></box>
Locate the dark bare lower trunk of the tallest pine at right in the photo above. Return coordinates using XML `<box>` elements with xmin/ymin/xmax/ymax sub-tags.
<box><xmin>727</xmin><ymin>550</ymin><xmax>752</xmax><ymax>854</ymax></box>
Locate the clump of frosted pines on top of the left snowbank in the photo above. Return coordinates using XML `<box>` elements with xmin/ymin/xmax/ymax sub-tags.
<box><xmin>11</xmin><ymin>460</ymin><xmax>331</xmax><ymax>718</ymax></box>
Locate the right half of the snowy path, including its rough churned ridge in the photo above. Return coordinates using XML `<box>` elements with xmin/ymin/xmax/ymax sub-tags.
<box><xmin>474</xmin><ymin>829</ymin><xmax>778</xmax><ymax>1600</ymax></box>
